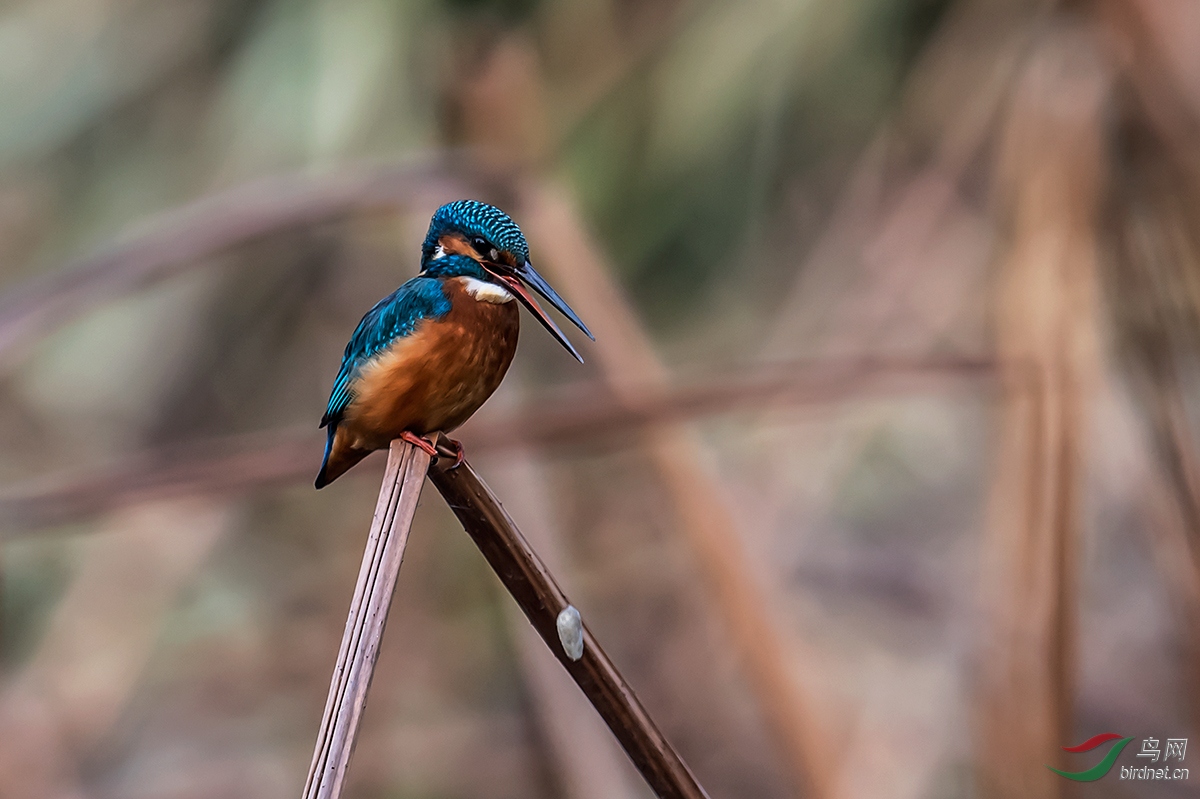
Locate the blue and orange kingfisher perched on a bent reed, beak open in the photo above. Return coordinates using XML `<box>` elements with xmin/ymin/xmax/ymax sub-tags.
<box><xmin>316</xmin><ymin>200</ymin><xmax>595</xmax><ymax>488</ymax></box>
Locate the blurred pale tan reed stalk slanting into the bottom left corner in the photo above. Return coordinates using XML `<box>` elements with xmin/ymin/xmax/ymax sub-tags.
<box><xmin>0</xmin><ymin>500</ymin><xmax>230</xmax><ymax>799</ymax></box>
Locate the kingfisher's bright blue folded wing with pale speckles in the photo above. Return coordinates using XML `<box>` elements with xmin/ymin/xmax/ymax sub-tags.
<box><xmin>320</xmin><ymin>277</ymin><xmax>450</xmax><ymax>427</ymax></box>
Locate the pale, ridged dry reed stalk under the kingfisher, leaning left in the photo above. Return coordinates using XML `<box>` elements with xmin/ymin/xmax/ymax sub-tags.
<box><xmin>304</xmin><ymin>440</ymin><xmax>430</xmax><ymax>799</ymax></box>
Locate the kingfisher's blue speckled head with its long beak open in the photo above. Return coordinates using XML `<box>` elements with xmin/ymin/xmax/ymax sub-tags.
<box><xmin>421</xmin><ymin>200</ymin><xmax>595</xmax><ymax>362</ymax></box>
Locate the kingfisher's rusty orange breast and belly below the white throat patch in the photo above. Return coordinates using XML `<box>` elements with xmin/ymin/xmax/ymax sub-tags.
<box><xmin>342</xmin><ymin>280</ymin><xmax>520</xmax><ymax>449</ymax></box>
